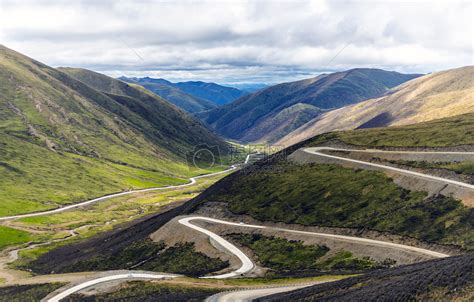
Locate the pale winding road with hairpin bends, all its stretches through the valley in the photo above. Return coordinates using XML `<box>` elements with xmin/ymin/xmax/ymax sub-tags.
<box><xmin>0</xmin><ymin>147</ymin><xmax>474</xmax><ymax>302</ymax></box>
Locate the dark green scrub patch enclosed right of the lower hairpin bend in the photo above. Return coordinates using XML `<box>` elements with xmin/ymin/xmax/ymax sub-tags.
<box><xmin>230</xmin><ymin>234</ymin><xmax>394</xmax><ymax>274</ymax></box>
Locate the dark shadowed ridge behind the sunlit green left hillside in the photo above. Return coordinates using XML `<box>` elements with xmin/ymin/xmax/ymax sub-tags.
<box><xmin>57</xmin><ymin>68</ymin><xmax>226</xmax><ymax>156</ymax></box>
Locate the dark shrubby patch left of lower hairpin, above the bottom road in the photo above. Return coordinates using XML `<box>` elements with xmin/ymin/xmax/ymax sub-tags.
<box><xmin>57</xmin><ymin>239</ymin><xmax>229</xmax><ymax>276</ymax></box>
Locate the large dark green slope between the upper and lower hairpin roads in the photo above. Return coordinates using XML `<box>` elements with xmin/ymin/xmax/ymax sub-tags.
<box><xmin>198</xmin><ymin>161</ymin><xmax>474</xmax><ymax>249</ymax></box>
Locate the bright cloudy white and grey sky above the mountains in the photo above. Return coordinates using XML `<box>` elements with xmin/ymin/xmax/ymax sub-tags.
<box><xmin>0</xmin><ymin>0</ymin><xmax>474</xmax><ymax>83</ymax></box>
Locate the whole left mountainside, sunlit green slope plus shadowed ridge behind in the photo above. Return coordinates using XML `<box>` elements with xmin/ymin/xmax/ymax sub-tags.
<box><xmin>0</xmin><ymin>46</ymin><xmax>230</xmax><ymax>216</ymax></box>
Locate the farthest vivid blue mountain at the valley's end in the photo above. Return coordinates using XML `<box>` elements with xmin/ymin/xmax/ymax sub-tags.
<box><xmin>119</xmin><ymin>77</ymin><xmax>247</xmax><ymax>113</ymax></box>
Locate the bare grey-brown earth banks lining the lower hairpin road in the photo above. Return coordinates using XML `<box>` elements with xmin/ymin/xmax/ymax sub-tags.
<box><xmin>150</xmin><ymin>203</ymin><xmax>460</xmax><ymax>276</ymax></box>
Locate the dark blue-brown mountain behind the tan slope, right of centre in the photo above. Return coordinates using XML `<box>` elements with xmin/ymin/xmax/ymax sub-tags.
<box><xmin>197</xmin><ymin>69</ymin><xmax>420</xmax><ymax>142</ymax></box>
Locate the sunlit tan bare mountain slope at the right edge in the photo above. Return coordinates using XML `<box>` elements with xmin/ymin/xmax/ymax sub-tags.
<box><xmin>278</xmin><ymin>66</ymin><xmax>474</xmax><ymax>145</ymax></box>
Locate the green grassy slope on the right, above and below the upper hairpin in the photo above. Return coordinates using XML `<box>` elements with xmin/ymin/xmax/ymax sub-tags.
<box><xmin>194</xmin><ymin>115</ymin><xmax>474</xmax><ymax>250</ymax></box>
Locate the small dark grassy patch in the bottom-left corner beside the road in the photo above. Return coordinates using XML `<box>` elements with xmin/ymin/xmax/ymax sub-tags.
<box><xmin>0</xmin><ymin>283</ymin><xmax>65</xmax><ymax>302</ymax></box>
